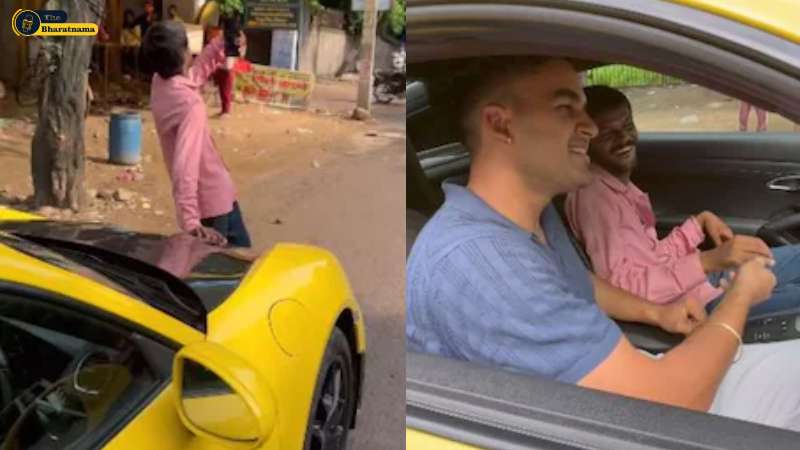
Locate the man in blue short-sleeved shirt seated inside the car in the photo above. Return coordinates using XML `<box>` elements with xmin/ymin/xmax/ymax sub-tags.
<box><xmin>406</xmin><ymin>57</ymin><xmax>800</xmax><ymax>429</ymax></box>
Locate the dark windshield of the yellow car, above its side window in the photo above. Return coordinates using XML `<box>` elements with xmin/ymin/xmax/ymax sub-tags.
<box><xmin>0</xmin><ymin>234</ymin><xmax>206</xmax><ymax>331</ymax></box>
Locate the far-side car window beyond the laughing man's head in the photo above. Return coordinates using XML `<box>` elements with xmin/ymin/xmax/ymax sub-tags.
<box><xmin>585</xmin><ymin>64</ymin><xmax>800</xmax><ymax>132</ymax></box>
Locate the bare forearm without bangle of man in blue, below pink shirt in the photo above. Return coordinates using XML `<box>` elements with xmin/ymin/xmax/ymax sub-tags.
<box><xmin>592</xmin><ymin>274</ymin><xmax>663</xmax><ymax>326</ymax></box>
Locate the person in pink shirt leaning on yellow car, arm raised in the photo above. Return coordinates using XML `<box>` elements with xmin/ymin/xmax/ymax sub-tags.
<box><xmin>142</xmin><ymin>21</ymin><xmax>250</xmax><ymax>247</ymax></box>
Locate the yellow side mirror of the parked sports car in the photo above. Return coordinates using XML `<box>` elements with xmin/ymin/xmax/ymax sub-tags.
<box><xmin>172</xmin><ymin>342</ymin><xmax>276</xmax><ymax>447</ymax></box>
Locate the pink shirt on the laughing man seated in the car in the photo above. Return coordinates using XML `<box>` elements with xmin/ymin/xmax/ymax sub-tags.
<box><xmin>566</xmin><ymin>166</ymin><xmax>722</xmax><ymax>303</ymax></box>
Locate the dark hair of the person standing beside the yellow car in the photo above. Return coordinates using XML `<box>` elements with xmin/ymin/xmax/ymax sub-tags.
<box><xmin>142</xmin><ymin>21</ymin><xmax>189</xmax><ymax>79</ymax></box>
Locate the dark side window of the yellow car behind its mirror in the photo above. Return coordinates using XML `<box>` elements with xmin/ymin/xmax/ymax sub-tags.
<box><xmin>0</xmin><ymin>294</ymin><xmax>172</xmax><ymax>449</ymax></box>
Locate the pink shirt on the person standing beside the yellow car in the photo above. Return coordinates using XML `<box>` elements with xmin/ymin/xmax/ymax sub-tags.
<box><xmin>150</xmin><ymin>38</ymin><xmax>236</xmax><ymax>231</ymax></box>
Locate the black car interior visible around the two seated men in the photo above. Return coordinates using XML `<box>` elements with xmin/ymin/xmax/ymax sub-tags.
<box><xmin>406</xmin><ymin>61</ymin><xmax>800</xmax><ymax>353</ymax></box>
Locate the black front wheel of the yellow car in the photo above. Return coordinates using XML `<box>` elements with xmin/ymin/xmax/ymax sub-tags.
<box><xmin>303</xmin><ymin>328</ymin><xmax>356</xmax><ymax>450</ymax></box>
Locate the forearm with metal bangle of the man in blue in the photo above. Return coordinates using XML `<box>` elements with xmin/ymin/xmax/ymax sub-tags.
<box><xmin>658</xmin><ymin>292</ymin><xmax>749</xmax><ymax>411</ymax></box>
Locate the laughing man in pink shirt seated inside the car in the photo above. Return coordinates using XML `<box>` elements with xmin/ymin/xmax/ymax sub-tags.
<box><xmin>566</xmin><ymin>86</ymin><xmax>800</xmax><ymax>317</ymax></box>
